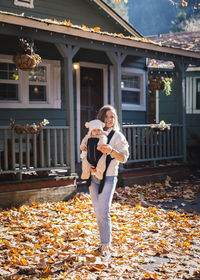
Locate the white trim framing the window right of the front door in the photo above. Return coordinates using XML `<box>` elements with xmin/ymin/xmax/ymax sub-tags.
<box><xmin>121</xmin><ymin>67</ymin><xmax>146</xmax><ymax>111</ymax></box>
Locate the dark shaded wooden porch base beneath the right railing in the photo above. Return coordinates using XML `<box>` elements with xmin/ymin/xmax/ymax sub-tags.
<box><xmin>120</xmin><ymin>165</ymin><xmax>190</xmax><ymax>187</ymax></box>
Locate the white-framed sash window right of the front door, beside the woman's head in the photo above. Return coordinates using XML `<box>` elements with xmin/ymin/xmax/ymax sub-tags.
<box><xmin>121</xmin><ymin>68</ymin><xmax>146</xmax><ymax>111</ymax></box>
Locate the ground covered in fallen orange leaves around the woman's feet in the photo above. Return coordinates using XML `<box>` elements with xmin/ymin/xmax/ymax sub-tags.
<box><xmin>0</xmin><ymin>173</ymin><xmax>200</xmax><ymax>280</ymax></box>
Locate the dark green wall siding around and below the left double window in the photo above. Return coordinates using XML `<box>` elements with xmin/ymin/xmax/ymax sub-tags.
<box><xmin>0</xmin><ymin>35</ymin><xmax>66</xmax><ymax>126</ymax></box>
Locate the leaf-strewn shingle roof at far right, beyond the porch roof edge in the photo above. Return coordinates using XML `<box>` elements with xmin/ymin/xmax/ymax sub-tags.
<box><xmin>146</xmin><ymin>32</ymin><xmax>200</xmax><ymax>52</ymax></box>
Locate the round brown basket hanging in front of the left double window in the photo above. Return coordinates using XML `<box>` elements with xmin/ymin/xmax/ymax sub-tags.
<box><xmin>13</xmin><ymin>53</ymin><xmax>41</xmax><ymax>71</ymax></box>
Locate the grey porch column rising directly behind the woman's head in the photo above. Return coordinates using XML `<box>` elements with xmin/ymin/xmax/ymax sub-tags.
<box><xmin>106</xmin><ymin>51</ymin><xmax>126</xmax><ymax>125</ymax></box>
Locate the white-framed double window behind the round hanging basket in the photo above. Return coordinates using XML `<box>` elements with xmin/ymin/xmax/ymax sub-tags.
<box><xmin>0</xmin><ymin>55</ymin><xmax>61</xmax><ymax>109</ymax></box>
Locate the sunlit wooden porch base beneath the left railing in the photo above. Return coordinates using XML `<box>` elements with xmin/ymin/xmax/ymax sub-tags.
<box><xmin>0</xmin><ymin>176</ymin><xmax>77</xmax><ymax>209</ymax></box>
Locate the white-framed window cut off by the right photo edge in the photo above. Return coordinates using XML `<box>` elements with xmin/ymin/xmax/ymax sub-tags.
<box><xmin>186</xmin><ymin>76</ymin><xmax>200</xmax><ymax>114</ymax></box>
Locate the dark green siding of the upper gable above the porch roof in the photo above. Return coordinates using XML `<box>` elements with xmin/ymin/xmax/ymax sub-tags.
<box><xmin>1</xmin><ymin>0</ymin><xmax>130</xmax><ymax>35</ymax></box>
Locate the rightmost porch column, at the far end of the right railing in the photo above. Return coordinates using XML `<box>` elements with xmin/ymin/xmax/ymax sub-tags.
<box><xmin>174</xmin><ymin>61</ymin><xmax>188</xmax><ymax>162</ymax></box>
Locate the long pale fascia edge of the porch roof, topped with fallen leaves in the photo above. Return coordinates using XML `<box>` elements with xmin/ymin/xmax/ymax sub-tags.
<box><xmin>0</xmin><ymin>11</ymin><xmax>200</xmax><ymax>59</ymax></box>
